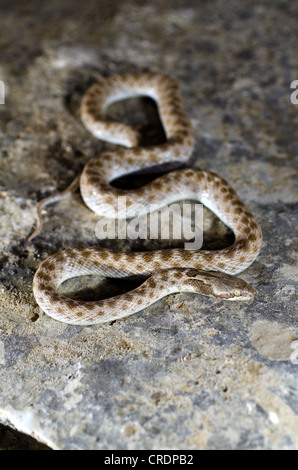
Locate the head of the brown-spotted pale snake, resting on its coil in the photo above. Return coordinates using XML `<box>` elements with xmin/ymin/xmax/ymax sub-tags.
<box><xmin>186</xmin><ymin>269</ymin><xmax>256</xmax><ymax>302</ymax></box>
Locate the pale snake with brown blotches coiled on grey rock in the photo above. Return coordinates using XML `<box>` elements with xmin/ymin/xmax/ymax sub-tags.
<box><xmin>30</xmin><ymin>72</ymin><xmax>262</xmax><ymax>325</ymax></box>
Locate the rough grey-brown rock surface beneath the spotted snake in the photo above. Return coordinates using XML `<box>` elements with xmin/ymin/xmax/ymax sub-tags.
<box><xmin>0</xmin><ymin>0</ymin><xmax>298</xmax><ymax>449</ymax></box>
